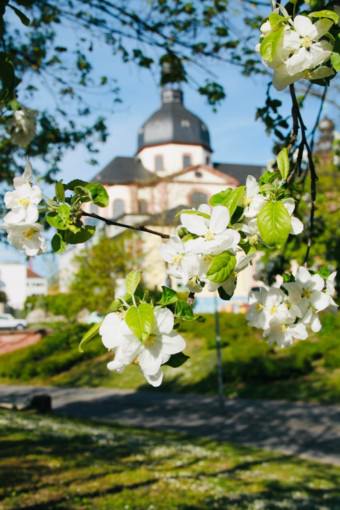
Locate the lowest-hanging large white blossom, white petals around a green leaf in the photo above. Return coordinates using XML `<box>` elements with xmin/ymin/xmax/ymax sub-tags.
<box><xmin>99</xmin><ymin>307</ymin><xmax>185</xmax><ymax>386</ymax></box>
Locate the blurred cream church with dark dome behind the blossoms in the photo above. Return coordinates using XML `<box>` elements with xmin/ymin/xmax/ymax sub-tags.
<box><xmin>60</xmin><ymin>87</ymin><xmax>262</xmax><ymax>311</ymax></box>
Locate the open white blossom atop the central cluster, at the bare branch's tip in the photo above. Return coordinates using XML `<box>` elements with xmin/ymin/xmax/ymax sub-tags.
<box><xmin>181</xmin><ymin>205</ymin><xmax>241</xmax><ymax>255</ymax></box>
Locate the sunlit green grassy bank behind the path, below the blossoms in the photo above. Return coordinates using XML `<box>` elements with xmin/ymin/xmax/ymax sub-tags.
<box><xmin>0</xmin><ymin>314</ymin><xmax>340</xmax><ymax>402</ymax></box>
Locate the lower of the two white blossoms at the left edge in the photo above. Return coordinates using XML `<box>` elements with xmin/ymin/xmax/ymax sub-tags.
<box><xmin>3</xmin><ymin>223</ymin><xmax>46</xmax><ymax>256</ymax></box>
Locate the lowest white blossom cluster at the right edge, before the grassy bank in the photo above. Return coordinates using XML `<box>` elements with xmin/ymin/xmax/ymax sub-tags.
<box><xmin>247</xmin><ymin>266</ymin><xmax>337</xmax><ymax>347</ymax></box>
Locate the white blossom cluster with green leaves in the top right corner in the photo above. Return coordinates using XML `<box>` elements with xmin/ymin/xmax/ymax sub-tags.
<box><xmin>257</xmin><ymin>11</ymin><xmax>337</xmax><ymax>90</ymax></box>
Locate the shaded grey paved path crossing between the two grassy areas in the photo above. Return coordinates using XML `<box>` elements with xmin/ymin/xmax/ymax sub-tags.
<box><xmin>0</xmin><ymin>385</ymin><xmax>340</xmax><ymax>465</ymax></box>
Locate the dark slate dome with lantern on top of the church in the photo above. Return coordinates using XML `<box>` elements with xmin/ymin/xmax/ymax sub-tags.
<box><xmin>138</xmin><ymin>88</ymin><xmax>211</xmax><ymax>152</ymax></box>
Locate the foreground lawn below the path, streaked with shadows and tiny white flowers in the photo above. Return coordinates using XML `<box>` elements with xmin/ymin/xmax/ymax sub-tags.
<box><xmin>0</xmin><ymin>411</ymin><xmax>340</xmax><ymax>510</ymax></box>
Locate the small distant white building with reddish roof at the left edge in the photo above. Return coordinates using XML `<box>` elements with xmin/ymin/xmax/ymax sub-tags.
<box><xmin>0</xmin><ymin>262</ymin><xmax>48</xmax><ymax>310</ymax></box>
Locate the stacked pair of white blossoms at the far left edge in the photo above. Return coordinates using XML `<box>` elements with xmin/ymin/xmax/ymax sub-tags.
<box><xmin>3</xmin><ymin>162</ymin><xmax>45</xmax><ymax>256</ymax></box>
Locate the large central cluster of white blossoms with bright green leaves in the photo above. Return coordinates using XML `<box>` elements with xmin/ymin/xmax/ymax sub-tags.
<box><xmin>160</xmin><ymin>173</ymin><xmax>303</xmax><ymax>299</ymax></box>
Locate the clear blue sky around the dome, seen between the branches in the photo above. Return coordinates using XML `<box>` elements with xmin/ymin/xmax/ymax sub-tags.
<box><xmin>0</xmin><ymin>14</ymin><xmax>335</xmax><ymax>275</ymax></box>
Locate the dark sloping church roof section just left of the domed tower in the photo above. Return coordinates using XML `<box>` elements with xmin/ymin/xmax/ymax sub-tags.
<box><xmin>94</xmin><ymin>156</ymin><xmax>155</xmax><ymax>184</ymax></box>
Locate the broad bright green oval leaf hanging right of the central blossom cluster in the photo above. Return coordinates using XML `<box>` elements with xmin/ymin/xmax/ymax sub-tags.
<box><xmin>257</xmin><ymin>201</ymin><xmax>291</xmax><ymax>245</ymax></box>
